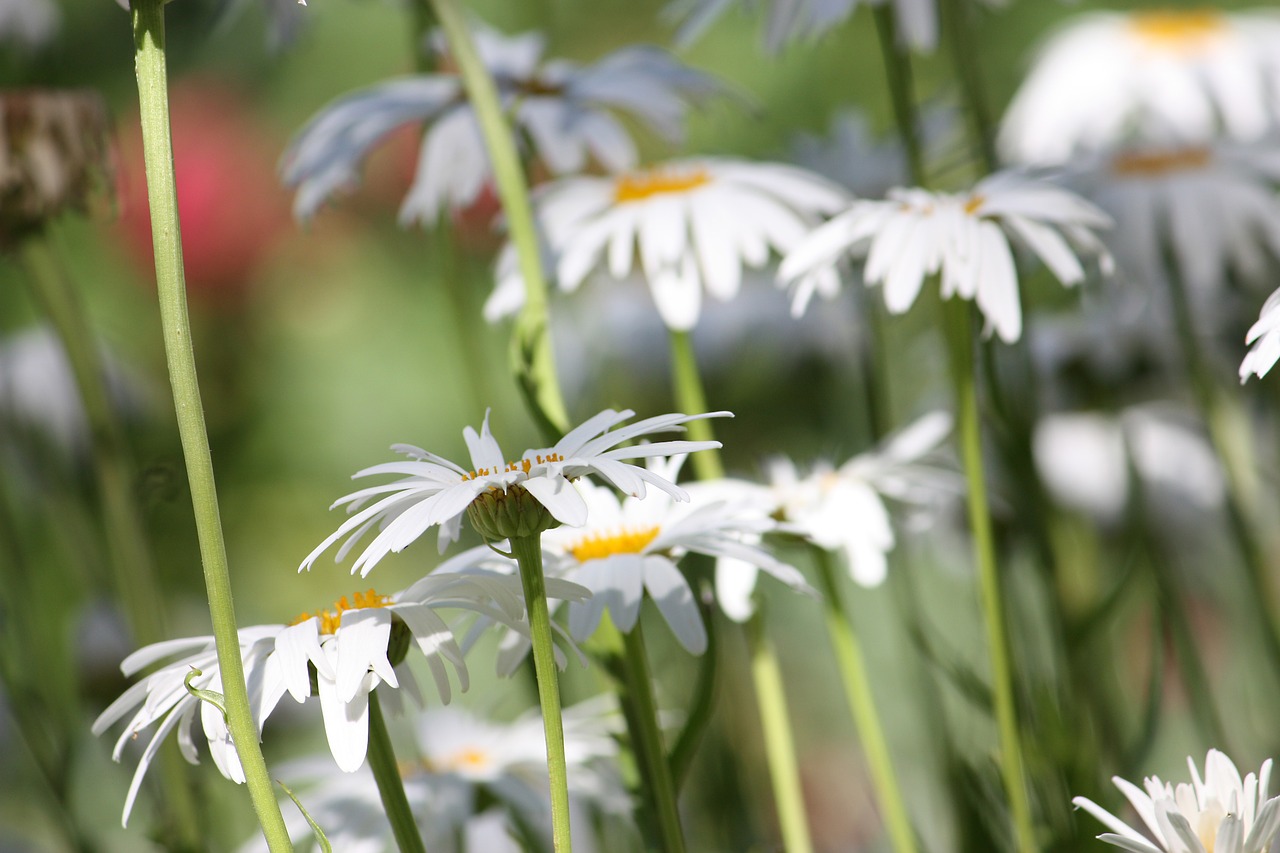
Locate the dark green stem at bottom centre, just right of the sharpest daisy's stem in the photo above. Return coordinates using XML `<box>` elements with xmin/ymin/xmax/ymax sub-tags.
<box><xmin>622</xmin><ymin>621</ymin><xmax>685</xmax><ymax>853</ymax></box>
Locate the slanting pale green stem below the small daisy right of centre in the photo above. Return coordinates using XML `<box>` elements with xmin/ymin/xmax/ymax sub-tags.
<box><xmin>810</xmin><ymin>547</ymin><xmax>916</xmax><ymax>853</ymax></box>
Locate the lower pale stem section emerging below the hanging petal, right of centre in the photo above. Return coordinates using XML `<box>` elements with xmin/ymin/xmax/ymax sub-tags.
<box><xmin>746</xmin><ymin>608</ymin><xmax>813</xmax><ymax>853</ymax></box>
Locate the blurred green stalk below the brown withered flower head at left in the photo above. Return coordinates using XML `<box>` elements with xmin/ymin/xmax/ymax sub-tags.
<box><xmin>20</xmin><ymin>234</ymin><xmax>201</xmax><ymax>849</ymax></box>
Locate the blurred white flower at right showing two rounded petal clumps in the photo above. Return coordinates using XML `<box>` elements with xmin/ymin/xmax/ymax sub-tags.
<box><xmin>1033</xmin><ymin>406</ymin><xmax>1225</xmax><ymax>523</ymax></box>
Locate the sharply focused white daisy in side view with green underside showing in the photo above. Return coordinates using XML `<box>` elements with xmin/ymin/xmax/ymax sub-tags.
<box><xmin>298</xmin><ymin>409</ymin><xmax>732</xmax><ymax>576</ymax></box>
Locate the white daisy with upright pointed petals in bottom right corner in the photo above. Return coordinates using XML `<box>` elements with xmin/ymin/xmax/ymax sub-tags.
<box><xmin>1071</xmin><ymin>749</ymin><xmax>1280</xmax><ymax>853</ymax></box>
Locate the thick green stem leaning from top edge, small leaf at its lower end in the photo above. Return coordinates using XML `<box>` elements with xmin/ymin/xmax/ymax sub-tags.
<box><xmin>430</xmin><ymin>0</ymin><xmax>568</xmax><ymax>438</ymax></box>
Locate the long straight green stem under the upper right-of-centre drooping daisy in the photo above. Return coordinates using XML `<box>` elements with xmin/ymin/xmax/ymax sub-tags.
<box><xmin>943</xmin><ymin>300</ymin><xmax>1039</xmax><ymax>853</ymax></box>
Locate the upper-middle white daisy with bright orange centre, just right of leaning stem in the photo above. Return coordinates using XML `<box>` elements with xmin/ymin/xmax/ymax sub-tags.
<box><xmin>486</xmin><ymin>158</ymin><xmax>847</xmax><ymax>332</ymax></box>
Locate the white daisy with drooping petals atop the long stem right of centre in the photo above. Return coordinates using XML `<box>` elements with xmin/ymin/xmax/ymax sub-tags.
<box><xmin>778</xmin><ymin>172</ymin><xmax>1111</xmax><ymax>342</ymax></box>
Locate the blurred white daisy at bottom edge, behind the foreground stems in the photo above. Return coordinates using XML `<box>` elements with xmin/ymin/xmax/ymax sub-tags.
<box><xmin>241</xmin><ymin>699</ymin><xmax>630</xmax><ymax>853</ymax></box>
